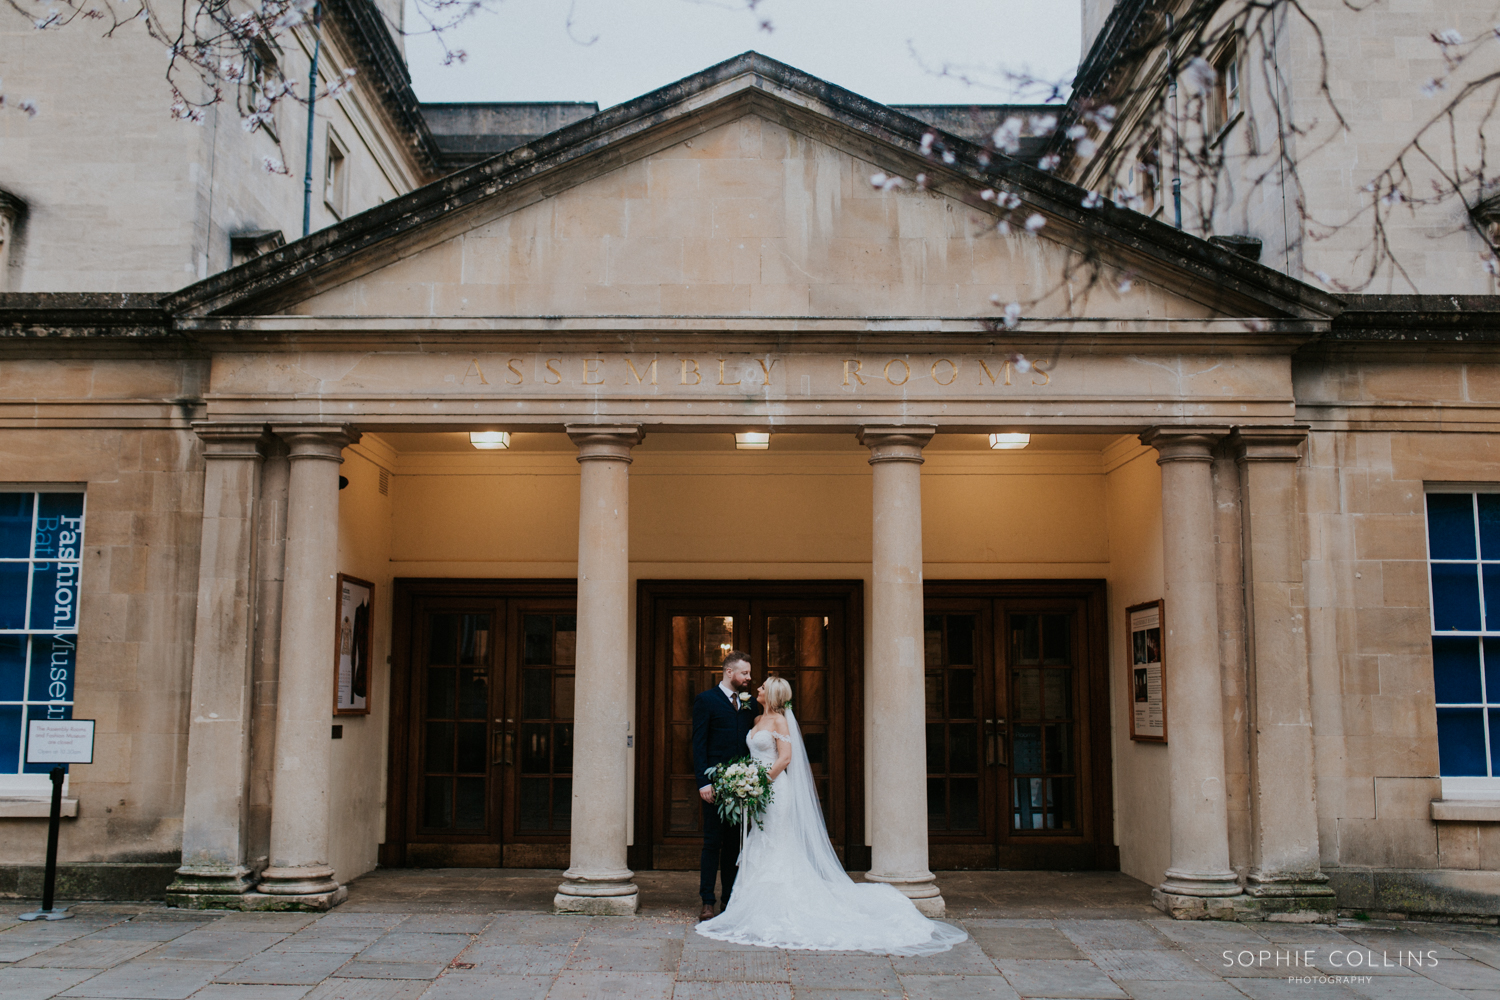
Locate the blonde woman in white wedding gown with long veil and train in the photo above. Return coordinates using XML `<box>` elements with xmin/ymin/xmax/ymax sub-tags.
<box><xmin>698</xmin><ymin>676</ymin><xmax>968</xmax><ymax>955</ymax></box>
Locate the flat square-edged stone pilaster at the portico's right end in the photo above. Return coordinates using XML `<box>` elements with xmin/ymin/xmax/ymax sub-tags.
<box><xmin>1232</xmin><ymin>427</ymin><xmax>1335</xmax><ymax>919</ymax></box>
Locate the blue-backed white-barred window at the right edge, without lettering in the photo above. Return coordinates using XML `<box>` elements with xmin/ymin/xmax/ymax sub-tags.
<box><xmin>1427</xmin><ymin>492</ymin><xmax>1500</xmax><ymax>795</ymax></box>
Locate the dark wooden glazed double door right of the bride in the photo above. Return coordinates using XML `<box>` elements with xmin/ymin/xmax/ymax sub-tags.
<box><xmin>923</xmin><ymin>580</ymin><xmax>1119</xmax><ymax>870</ymax></box>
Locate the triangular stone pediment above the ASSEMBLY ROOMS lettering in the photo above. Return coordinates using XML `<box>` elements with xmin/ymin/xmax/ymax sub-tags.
<box><xmin>174</xmin><ymin>54</ymin><xmax>1329</xmax><ymax>321</ymax></box>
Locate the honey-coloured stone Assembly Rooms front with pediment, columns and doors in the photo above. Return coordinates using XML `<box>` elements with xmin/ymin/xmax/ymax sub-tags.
<box><xmin>0</xmin><ymin>3</ymin><xmax>1500</xmax><ymax>919</ymax></box>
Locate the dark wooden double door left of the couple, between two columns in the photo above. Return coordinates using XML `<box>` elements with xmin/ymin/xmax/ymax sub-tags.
<box><xmin>381</xmin><ymin>580</ymin><xmax>578</xmax><ymax>868</ymax></box>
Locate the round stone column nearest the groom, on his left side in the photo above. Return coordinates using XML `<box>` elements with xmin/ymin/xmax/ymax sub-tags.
<box><xmin>552</xmin><ymin>426</ymin><xmax>642</xmax><ymax>916</ymax></box>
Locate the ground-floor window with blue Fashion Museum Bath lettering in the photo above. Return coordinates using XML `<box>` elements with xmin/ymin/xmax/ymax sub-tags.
<box><xmin>0</xmin><ymin>490</ymin><xmax>84</xmax><ymax>793</ymax></box>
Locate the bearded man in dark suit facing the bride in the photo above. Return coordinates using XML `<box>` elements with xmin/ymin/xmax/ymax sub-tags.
<box><xmin>693</xmin><ymin>649</ymin><xmax>761</xmax><ymax>921</ymax></box>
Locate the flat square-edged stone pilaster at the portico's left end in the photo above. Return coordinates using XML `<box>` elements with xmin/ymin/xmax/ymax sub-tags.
<box><xmin>167</xmin><ymin>421</ymin><xmax>266</xmax><ymax>907</ymax></box>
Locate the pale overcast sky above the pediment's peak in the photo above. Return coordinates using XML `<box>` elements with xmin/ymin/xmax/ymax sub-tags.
<box><xmin>407</xmin><ymin>0</ymin><xmax>1080</xmax><ymax>108</ymax></box>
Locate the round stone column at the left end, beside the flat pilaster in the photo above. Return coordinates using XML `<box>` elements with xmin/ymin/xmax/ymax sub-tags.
<box><xmin>260</xmin><ymin>424</ymin><xmax>360</xmax><ymax>910</ymax></box>
